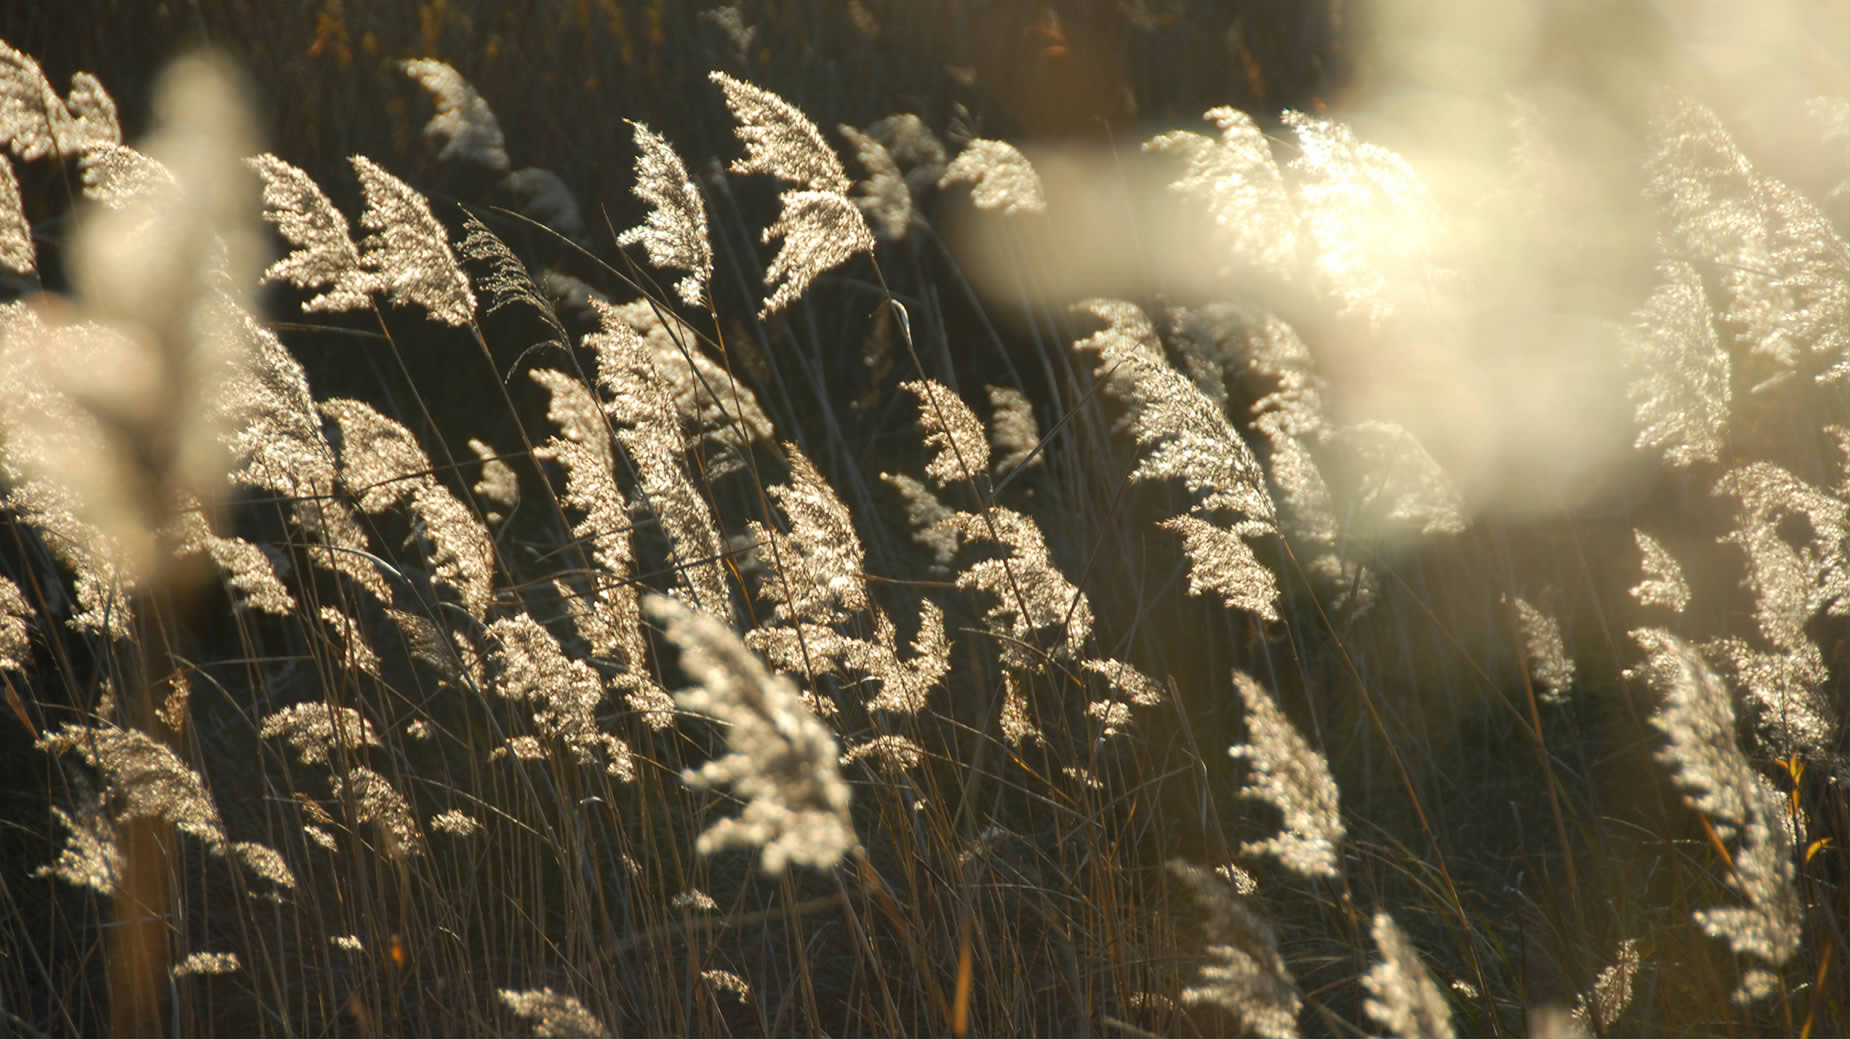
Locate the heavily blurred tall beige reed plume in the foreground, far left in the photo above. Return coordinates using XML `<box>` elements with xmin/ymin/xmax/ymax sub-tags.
<box><xmin>0</xmin><ymin>52</ymin><xmax>255</xmax><ymax>632</ymax></box>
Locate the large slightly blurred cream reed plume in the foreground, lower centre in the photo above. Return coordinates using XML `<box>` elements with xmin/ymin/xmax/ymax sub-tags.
<box><xmin>646</xmin><ymin>595</ymin><xmax>860</xmax><ymax>873</ymax></box>
